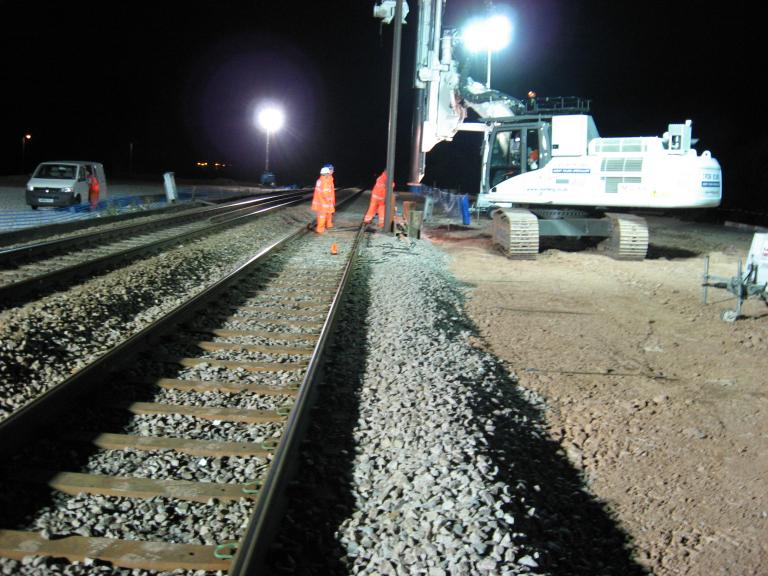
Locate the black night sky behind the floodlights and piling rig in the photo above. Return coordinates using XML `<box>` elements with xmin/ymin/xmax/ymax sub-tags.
<box><xmin>0</xmin><ymin>0</ymin><xmax>768</xmax><ymax>208</ymax></box>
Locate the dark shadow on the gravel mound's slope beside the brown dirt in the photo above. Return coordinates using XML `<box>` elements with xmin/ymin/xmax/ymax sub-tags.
<box><xmin>466</xmin><ymin>344</ymin><xmax>648</xmax><ymax>576</ymax></box>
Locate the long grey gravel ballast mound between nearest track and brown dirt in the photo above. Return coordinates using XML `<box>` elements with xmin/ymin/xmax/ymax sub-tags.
<box><xmin>270</xmin><ymin>235</ymin><xmax>642</xmax><ymax>575</ymax></box>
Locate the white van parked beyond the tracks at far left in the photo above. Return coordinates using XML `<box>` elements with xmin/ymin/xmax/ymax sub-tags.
<box><xmin>27</xmin><ymin>160</ymin><xmax>107</xmax><ymax>209</ymax></box>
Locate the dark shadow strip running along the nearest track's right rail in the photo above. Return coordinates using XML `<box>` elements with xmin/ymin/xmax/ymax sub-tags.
<box><xmin>264</xmin><ymin>259</ymin><xmax>370</xmax><ymax>576</ymax></box>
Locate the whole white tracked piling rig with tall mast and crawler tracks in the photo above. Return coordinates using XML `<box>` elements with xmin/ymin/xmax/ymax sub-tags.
<box><xmin>404</xmin><ymin>0</ymin><xmax>722</xmax><ymax>259</ymax></box>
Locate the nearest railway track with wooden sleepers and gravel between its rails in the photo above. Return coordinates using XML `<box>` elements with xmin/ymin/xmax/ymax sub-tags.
<box><xmin>0</xmin><ymin>215</ymin><xmax>363</xmax><ymax>574</ymax></box>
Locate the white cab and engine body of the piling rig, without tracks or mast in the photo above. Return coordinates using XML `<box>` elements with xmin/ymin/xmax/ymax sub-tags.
<box><xmin>477</xmin><ymin>115</ymin><xmax>722</xmax><ymax>209</ymax></box>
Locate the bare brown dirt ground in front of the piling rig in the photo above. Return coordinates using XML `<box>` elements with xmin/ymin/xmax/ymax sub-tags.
<box><xmin>422</xmin><ymin>216</ymin><xmax>768</xmax><ymax>576</ymax></box>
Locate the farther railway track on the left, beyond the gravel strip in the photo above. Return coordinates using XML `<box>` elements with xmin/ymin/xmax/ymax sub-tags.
<box><xmin>0</xmin><ymin>190</ymin><xmax>308</xmax><ymax>306</ymax></box>
